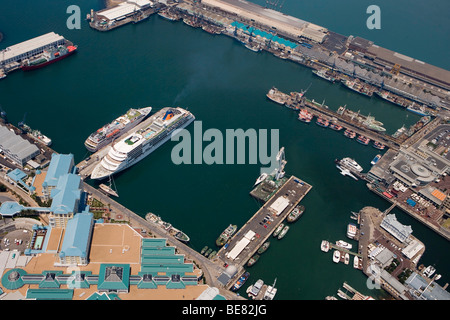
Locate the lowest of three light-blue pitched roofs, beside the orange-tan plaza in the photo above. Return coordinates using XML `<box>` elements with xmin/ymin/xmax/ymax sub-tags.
<box><xmin>59</xmin><ymin>212</ymin><xmax>93</xmax><ymax>258</ymax></box>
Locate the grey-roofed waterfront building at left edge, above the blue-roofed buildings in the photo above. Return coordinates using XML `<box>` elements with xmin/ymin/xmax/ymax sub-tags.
<box><xmin>0</xmin><ymin>126</ymin><xmax>40</xmax><ymax>168</ymax></box>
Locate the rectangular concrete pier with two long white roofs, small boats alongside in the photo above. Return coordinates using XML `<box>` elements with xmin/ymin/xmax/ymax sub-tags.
<box><xmin>216</xmin><ymin>176</ymin><xmax>312</xmax><ymax>288</ymax></box>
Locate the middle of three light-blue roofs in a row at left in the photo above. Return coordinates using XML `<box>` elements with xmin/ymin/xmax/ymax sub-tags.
<box><xmin>50</xmin><ymin>173</ymin><xmax>82</xmax><ymax>214</ymax></box>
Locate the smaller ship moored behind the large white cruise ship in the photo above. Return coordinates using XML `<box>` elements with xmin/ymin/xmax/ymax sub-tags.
<box><xmin>84</xmin><ymin>107</ymin><xmax>152</xmax><ymax>152</ymax></box>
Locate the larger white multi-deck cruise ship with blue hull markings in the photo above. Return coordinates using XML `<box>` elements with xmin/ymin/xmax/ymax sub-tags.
<box><xmin>91</xmin><ymin>108</ymin><xmax>195</xmax><ymax>179</ymax></box>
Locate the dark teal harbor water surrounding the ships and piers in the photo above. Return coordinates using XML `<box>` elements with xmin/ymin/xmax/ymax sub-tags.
<box><xmin>0</xmin><ymin>0</ymin><xmax>450</xmax><ymax>300</ymax></box>
